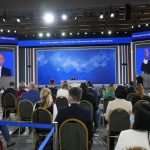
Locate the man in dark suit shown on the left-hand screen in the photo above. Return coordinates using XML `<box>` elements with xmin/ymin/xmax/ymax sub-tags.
<box><xmin>0</xmin><ymin>54</ymin><xmax>12</xmax><ymax>77</ymax></box>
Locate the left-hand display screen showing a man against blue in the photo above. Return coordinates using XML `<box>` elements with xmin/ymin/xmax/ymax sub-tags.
<box><xmin>0</xmin><ymin>50</ymin><xmax>15</xmax><ymax>77</ymax></box>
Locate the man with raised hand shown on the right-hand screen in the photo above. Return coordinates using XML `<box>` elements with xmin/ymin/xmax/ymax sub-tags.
<box><xmin>141</xmin><ymin>49</ymin><xmax>150</xmax><ymax>74</ymax></box>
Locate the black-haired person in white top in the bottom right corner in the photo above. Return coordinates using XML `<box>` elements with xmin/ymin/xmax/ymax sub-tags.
<box><xmin>115</xmin><ymin>100</ymin><xmax>150</xmax><ymax>150</ymax></box>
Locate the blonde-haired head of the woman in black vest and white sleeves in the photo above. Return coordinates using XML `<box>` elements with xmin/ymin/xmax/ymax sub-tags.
<box><xmin>40</xmin><ymin>88</ymin><xmax>53</xmax><ymax>108</ymax></box>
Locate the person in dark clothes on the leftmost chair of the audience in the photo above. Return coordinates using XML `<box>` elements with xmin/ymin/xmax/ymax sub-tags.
<box><xmin>1</xmin><ymin>82</ymin><xmax>17</xmax><ymax>118</ymax></box>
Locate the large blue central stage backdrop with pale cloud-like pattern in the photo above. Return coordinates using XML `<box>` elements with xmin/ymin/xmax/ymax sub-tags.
<box><xmin>36</xmin><ymin>48</ymin><xmax>116</xmax><ymax>85</ymax></box>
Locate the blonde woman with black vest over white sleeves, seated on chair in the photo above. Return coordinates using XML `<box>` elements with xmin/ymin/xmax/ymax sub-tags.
<box><xmin>35</xmin><ymin>88</ymin><xmax>58</xmax><ymax>121</ymax></box>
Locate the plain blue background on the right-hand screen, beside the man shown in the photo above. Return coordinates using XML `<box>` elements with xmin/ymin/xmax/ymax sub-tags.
<box><xmin>136</xmin><ymin>47</ymin><xmax>150</xmax><ymax>75</ymax></box>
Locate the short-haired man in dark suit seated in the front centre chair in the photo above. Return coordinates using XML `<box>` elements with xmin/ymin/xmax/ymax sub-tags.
<box><xmin>56</xmin><ymin>87</ymin><xmax>93</xmax><ymax>147</ymax></box>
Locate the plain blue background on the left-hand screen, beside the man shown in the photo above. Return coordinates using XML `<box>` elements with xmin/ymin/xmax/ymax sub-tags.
<box><xmin>0</xmin><ymin>51</ymin><xmax>15</xmax><ymax>76</ymax></box>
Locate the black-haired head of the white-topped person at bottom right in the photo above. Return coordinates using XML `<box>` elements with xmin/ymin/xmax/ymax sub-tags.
<box><xmin>132</xmin><ymin>100</ymin><xmax>150</xmax><ymax>131</ymax></box>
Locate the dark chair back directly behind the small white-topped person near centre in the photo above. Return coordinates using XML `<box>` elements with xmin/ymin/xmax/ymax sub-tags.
<box><xmin>56</xmin><ymin>96</ymin><xmax>69</xmax><ymax>110</ymax></box>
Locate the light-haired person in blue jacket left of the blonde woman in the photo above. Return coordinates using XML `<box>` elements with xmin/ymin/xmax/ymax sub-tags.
<box><xmin>20</xmin><ymin>82</ymin><xmax>40</xmax><ymax>104</ymax></box>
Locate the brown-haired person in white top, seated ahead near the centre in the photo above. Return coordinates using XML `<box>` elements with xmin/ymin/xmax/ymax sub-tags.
<box><xmin>56</xmin><ymin>82</ymin><xmax>69</xmax><ymax>100</ymax></box>
